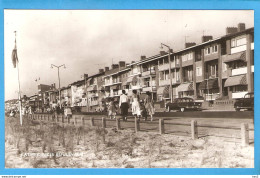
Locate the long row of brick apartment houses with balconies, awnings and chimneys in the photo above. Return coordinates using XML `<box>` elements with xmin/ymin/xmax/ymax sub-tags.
<box><xmin>24</xmin><ymin>23</ymin><xmax>254</xmax><ymax>111</ymax></box>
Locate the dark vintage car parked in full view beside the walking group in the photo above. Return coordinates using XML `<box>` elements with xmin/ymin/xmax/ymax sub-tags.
<box><xmin>165</xmin><ymin>97</ymin><xmax>202</xmax><ymax>112</ymax></box>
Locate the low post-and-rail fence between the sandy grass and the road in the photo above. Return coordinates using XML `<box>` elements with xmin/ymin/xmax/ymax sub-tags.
<box><xmin>26</xmin><ymin>114</ymin><xmax>254</xmax><ymax>146</ymax></box>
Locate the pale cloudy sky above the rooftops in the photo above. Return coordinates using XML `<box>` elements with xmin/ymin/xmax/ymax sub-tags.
<box><xmin>4</xmin><ymin>10</ymin><xmax>254</xmax><ymax>100</ymax></box>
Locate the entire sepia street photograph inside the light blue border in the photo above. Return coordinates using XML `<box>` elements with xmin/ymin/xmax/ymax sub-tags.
<box><xmin>4</xmin><ymin>9</ymin><xmax>255</xmax><ymax>168</ymax></box>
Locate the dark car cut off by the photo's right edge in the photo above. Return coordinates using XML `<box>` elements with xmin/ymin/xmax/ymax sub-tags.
<box><xmin>234</xmin><ymin>93</ymin><xmax>254</xmax><ymax>111</ymax></box>
